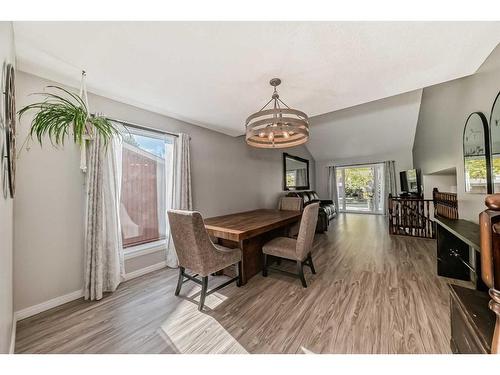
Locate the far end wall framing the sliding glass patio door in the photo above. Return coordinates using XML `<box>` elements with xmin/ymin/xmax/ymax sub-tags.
<box><xmin>316</xmin><ymin>149</ymin><xmax>413</xmax><ymax>199</ymax></box>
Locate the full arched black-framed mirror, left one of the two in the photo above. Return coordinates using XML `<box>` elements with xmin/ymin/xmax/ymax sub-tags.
<box><xmin>463</xmin><ymin>112</ymin><xmax>492</xmax><ymax>194</ymax></box>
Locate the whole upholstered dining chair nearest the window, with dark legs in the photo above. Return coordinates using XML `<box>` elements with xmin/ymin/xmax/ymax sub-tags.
<box><xmin>167</xmin><ymin>210</ymin><xmax>241</xmax><ymax>311</ymax></box>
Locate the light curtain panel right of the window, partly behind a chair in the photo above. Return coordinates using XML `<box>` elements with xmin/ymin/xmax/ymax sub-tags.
<box><xmin>167</xmin><ymin>133</ymin><xmax>193</xmax><ymax>268</ymax></box>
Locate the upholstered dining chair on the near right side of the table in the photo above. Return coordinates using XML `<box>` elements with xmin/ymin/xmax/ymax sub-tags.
<box><xmin>262</xmin><ymin>203</ymin><xmax>319</xmax><ymax>288</ymax></box>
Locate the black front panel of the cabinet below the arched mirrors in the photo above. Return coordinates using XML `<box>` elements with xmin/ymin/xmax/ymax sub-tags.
<box><xmin>436</xmin><ymin>225</ymin><xmax>471</xmax><ymax>281</ymax></box>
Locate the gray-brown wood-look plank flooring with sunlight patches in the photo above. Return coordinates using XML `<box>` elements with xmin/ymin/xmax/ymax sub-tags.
<box><xmin>16</xmin><ymin>214</ymin><xmax>450</xmax><ymax>353</ymax></box>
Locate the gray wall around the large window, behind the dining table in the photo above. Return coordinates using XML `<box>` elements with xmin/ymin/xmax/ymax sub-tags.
<box><xmin>14</xmin><ymin>73</ymin><xmax>315</xmax><ymax>310</ymax></box>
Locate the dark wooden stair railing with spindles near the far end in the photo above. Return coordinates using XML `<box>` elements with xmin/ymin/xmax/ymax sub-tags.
<box><xmin>389</xmin><ymin>195</ymin><xmax>436</xmax><ymax>238</ymax></box>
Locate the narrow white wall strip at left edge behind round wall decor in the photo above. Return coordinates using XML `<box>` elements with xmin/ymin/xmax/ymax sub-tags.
<box><xmin>0</xmin><ymin>22</ymin><xmax>15</xmax><ymax>353</ymax></box>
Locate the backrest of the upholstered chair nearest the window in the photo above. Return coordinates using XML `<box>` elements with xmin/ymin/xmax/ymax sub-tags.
<box><xmin>167</xmin><ymin>210</ymin><xmax>215</xmax><ymax>275</ymax></box>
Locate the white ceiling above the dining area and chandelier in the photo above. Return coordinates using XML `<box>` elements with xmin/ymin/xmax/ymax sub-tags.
<box><xmin>14</xmin><ymin>22</ymin><xmax>500</xmax><ymax>138</ymax></box>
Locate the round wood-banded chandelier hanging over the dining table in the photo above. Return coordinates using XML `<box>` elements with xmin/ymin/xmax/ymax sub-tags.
<box><xmin>245</xmin><ymin>78</ymin><xmax>309</xmax><ymax>148</ymax></box>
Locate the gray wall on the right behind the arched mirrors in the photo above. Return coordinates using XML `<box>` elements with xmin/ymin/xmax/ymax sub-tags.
<box><xmin>413</xmin><ymin>42</ymin><xmax>500</xmax><ymax>222</ymax></box>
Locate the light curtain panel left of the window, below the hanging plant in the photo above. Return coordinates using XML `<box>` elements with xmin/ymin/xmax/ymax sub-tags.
<box><xmin>84</xmin><ymin>137</ymin><xmax>125</xmax><ymax>300</ymax></box>
